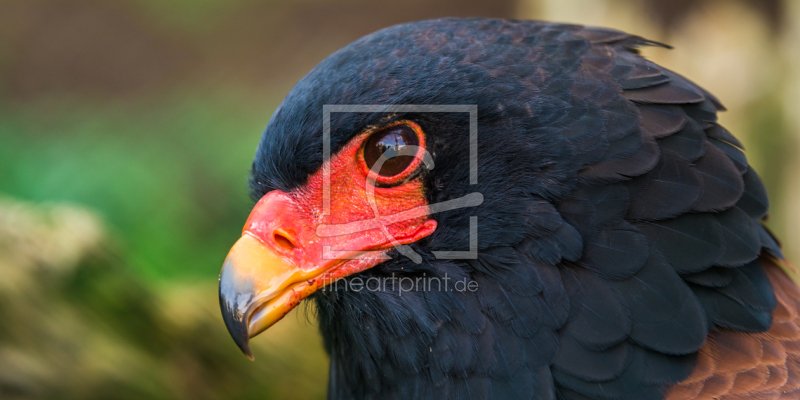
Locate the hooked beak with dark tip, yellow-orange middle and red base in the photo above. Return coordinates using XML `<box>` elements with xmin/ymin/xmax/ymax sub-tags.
<box><xmin>219</xmin><ymin>191</ymin><xmax>436</xmax><ymax>359</ymax></box>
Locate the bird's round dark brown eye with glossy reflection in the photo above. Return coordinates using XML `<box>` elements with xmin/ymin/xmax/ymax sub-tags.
<box><xmin>364</xmin><ymin>124</ymin><xmax>420</xmax><ymax>177</ymax></box>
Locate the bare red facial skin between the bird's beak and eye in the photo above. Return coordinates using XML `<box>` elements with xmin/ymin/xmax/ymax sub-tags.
<box><xmin>243</xmin><ymin>121</ymin><xmax>436</xmax><ymax>298</ymax></box>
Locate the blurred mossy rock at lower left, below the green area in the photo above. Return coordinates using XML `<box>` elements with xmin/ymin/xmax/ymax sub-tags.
<box><xmin>0</xmin><ymin>198</ymin><xmax>327</xmax><ymax>399</ymax></box>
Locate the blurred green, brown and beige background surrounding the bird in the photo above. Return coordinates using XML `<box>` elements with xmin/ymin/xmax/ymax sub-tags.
<box><xmin>0</xmin><ymin>0</ymin><xmax>800</xmax><ymax>399</ymax></box>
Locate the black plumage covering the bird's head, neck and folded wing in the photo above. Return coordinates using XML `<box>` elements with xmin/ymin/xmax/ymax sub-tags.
<box><xmin>251</xmin><ymin>19</ymin><xmax>780</xmax><ymax>399</ymax></box>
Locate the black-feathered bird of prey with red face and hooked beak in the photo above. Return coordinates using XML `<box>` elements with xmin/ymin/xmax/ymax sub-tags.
<box><xmin>219</xmin><ymin>18</ymin><xmax>800</xmax><ymax>400</ymax></box>
